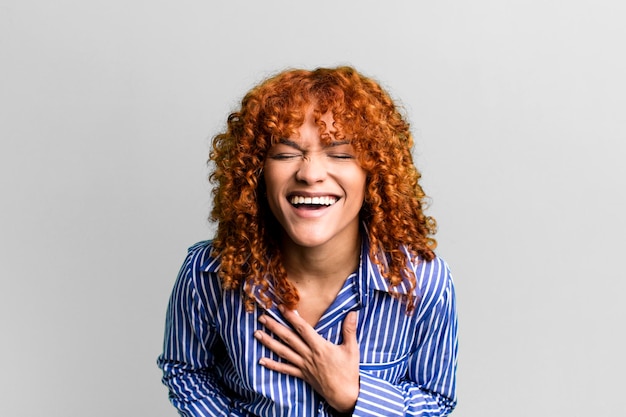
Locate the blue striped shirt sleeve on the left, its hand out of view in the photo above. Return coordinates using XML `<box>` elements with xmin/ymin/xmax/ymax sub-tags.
<box><xmin>157</xmin><ymin>248</ymin><xmax>231</xmax><ymax>417</ymax></box>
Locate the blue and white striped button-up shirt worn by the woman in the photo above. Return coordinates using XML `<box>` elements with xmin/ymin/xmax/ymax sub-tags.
<box><xmin>158</xmin><ymin>239</ymin><xmax>457</xmax><ymax>417</ymax></box>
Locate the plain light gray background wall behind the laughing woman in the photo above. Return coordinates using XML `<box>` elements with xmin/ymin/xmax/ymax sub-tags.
<box><xmin>0</xmin><ymin>0</ymin><xmax>626</xmax><ymax>417</ymax></box>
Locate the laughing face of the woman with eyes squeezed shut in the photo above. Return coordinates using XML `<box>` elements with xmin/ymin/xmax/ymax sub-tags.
<box><xmin>264</xmin><ymin>109</ymin><xmax>366</xmax><ymax>249</ymax></box>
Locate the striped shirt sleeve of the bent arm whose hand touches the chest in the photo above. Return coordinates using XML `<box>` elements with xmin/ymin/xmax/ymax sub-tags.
<box><xmin>353</xmin><ymin>261</ymin><xmax>457</xmax><ymax>417</ymax></box>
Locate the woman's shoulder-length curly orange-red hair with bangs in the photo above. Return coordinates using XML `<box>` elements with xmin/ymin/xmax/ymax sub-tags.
<box><xmin>209</xmin><ymin>67</ymin><xmax>436</xmax><ymax>312</ymax></box>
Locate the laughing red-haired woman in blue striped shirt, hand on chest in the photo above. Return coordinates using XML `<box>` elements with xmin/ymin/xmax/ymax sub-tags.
<box><xmin>158</xmin><ymin>67</ymin><xmax>457</xmax><ymax>416</ymax></box>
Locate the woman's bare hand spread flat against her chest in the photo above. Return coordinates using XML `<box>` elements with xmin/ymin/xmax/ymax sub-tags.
<box><xmin>254</xmin><ymin>309</ymin><xmax>359</xmax><ymax>413</ymax></box>
